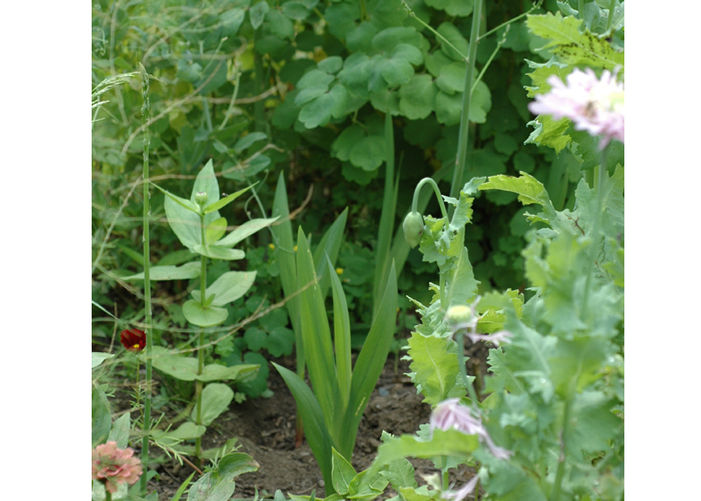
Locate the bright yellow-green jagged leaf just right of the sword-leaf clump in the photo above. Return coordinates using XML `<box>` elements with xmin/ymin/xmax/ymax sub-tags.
<box><xmin>408</xmin><ymin>332</ymin><xmax>465</xmax><ymax>405</ymax></box>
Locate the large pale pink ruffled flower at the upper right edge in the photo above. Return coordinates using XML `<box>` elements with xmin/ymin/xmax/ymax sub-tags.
<box><xmin>528</xmin><ymin>68</ymin><xmax>624</xmax><ymax>148</ymax></box>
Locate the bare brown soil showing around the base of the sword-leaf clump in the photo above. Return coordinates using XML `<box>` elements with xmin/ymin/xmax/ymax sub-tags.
<box><xmin>149</xmin><ymin>350</ymin><xmax>486</xmax><ymax>500</ymax></box>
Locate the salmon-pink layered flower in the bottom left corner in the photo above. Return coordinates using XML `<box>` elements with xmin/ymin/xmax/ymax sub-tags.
<box><xmin>92</xmin><ymin>441</ymin><xmax>142</xmax><ymax>494</ymax></box>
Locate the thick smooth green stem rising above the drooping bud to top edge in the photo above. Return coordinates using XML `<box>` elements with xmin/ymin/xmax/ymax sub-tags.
<box><xmin>450</xmin><ymin>0</ymin><xmax>482</xmax><ymax>201</ymax></box>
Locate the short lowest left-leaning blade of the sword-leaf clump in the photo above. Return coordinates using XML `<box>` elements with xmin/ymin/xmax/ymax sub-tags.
<box><xmin>271</xmin><ymin>362</ymin><xmax>334</xmax><ymax>486</ymax></box>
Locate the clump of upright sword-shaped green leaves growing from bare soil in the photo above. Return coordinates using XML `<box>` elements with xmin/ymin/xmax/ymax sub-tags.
<box><xmin>274</xmin><ymin>228</ymin><xmax>397</xmax><ymax>494</ymax></box>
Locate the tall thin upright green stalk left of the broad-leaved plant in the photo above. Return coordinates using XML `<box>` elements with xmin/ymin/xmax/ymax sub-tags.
<box><xmin>140</xmin><ymin>66</ymin><xmax>153</xmax><ymax>494</ymax></box>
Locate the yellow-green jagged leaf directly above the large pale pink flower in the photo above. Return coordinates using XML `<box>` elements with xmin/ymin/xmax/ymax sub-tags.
<box><xmin>526</xmin><ymin>12</ymin><xmax>624</xmax><ymax>70</ymax></box>
